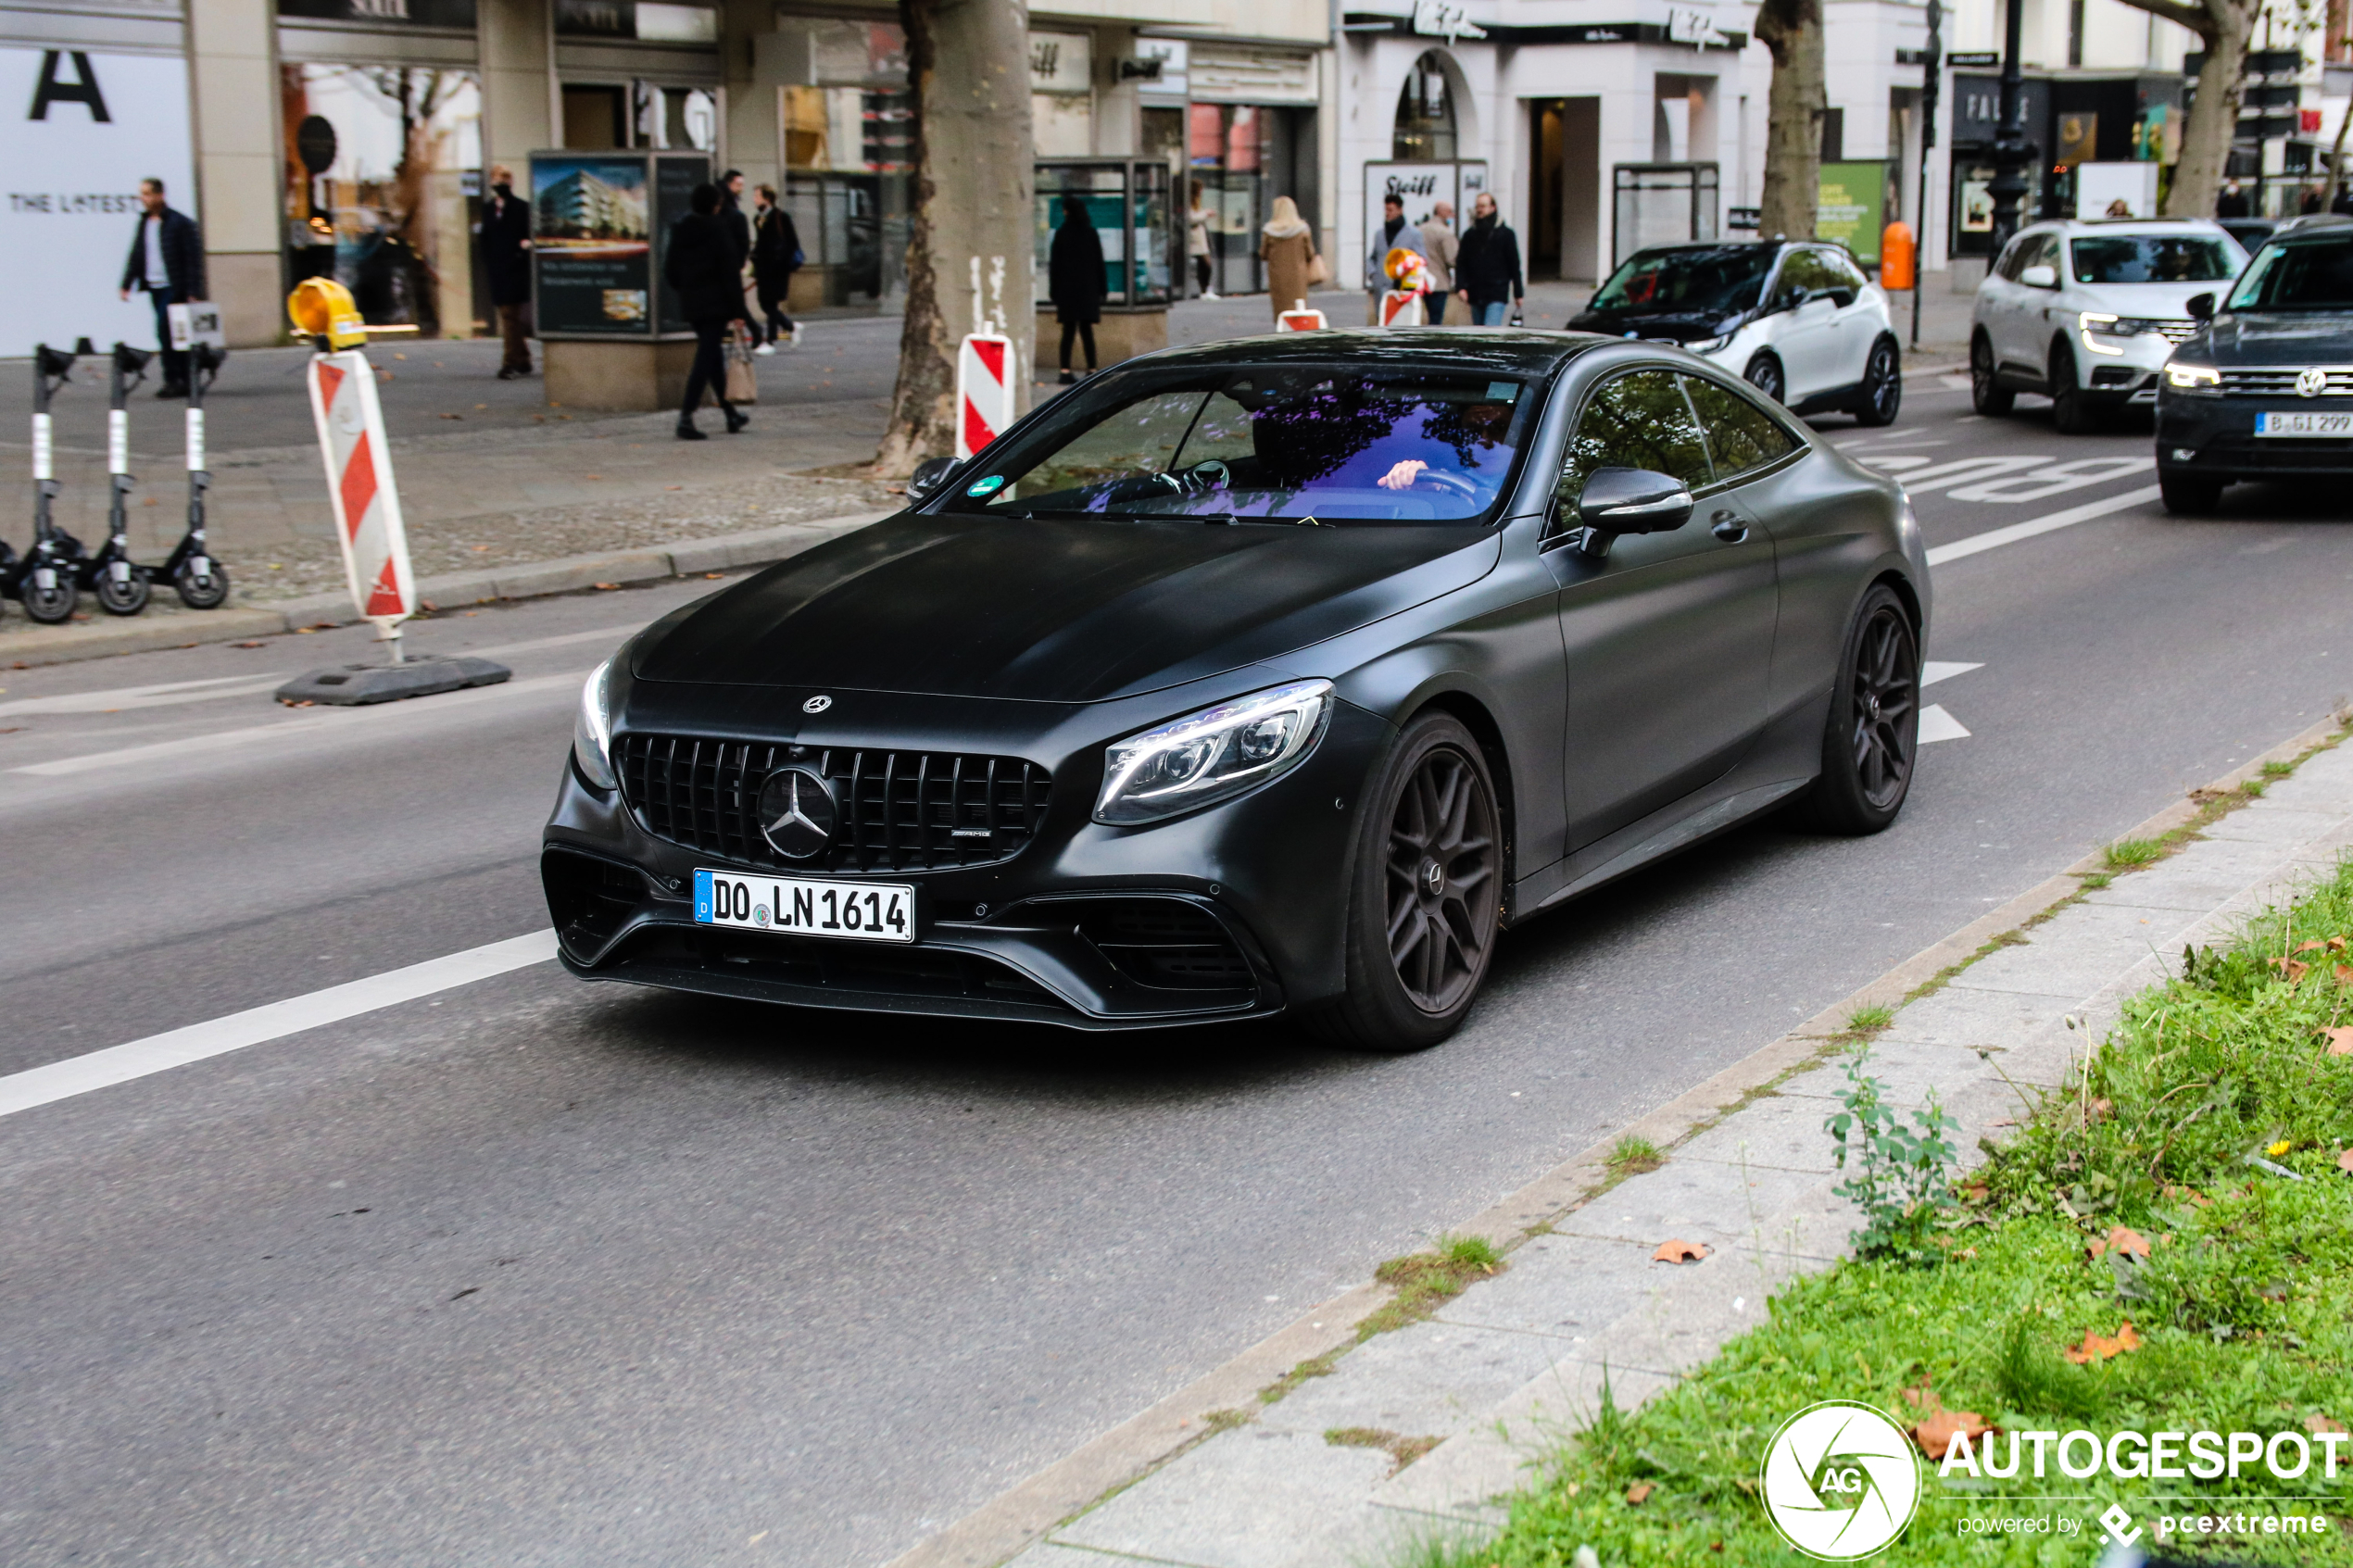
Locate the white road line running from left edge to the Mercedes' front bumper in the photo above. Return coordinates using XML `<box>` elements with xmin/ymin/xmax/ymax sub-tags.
<box><xmin>0</xmin><ymin>931</ymin><xmax>555</xmax><ymax>1117</ymax></box>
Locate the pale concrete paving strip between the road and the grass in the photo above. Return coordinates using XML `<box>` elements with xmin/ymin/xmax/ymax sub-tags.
<box><xmin>936</xmin><ymin>721</ymin><xmax>2353</xmax><ymax>1568</ymax></box>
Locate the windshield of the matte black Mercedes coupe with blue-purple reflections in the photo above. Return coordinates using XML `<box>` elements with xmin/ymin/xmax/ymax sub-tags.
<box><xmin>944</xmin><ymin>364</ymin><xmax>1539</xmax><ymax>524</ymax></box>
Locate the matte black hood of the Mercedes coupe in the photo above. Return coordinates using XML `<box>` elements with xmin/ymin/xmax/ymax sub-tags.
<box><xmin>631</xmin><ymin>512</ymin><xmax>1502</xmax><ymax>703</ymax></box>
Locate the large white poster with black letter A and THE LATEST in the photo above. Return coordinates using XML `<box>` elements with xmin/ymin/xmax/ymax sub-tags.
<box><xmin>0</xmin><ymin>49</ymin><xmax>205</xmax><ymax>359</ymax></box>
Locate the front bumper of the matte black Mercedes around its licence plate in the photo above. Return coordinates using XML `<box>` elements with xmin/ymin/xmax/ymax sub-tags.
<box><xmin>541</xmin><ymin>694</ymin><xmax>1393</xmax><ymax>1030</ymax></box>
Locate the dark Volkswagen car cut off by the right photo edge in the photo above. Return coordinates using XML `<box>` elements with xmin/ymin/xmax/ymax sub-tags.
<box><xmin>2158</xmin><ymin>217</ymin><xmax>2353</xmax><ymax>515</ymax></box>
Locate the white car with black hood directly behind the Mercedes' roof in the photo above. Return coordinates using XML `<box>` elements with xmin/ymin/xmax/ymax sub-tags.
<box><xmin>1569</xmin><ymin>240</ymin><xmax>1904</xmax><ymax>425</ymax></box>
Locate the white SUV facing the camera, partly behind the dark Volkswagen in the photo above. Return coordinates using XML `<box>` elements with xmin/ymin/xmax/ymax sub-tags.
<box><xmin>1969</xmin><ymin>219</ymin><xmax>2247</xmax><ymax>435</ymax></box>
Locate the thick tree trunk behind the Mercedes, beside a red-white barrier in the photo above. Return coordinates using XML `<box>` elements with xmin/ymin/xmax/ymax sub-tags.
<box><xmin>873</xmin><ymin>0</ymin><xmax>1038</xmax><ymax>480</ymax></box>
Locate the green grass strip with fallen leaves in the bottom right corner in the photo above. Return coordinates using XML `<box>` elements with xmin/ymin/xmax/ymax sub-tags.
<box><xmin>1409</xmin><ymin>865</ymin><xmax>2353</xmax><ymax>1568</ymax></box>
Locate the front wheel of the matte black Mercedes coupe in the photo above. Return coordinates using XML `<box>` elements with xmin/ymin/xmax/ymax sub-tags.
<box><xmin>1311</xmin><ymin>712</ymin><xmax>1504</xmax><ymax>1051</ymax></box>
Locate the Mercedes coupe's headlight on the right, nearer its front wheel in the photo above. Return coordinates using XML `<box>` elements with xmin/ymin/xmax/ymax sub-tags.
<box><xmin>1094</xmin><ymin>680</ymin><xmax>1332</xmax><ymax>827</ymax></box>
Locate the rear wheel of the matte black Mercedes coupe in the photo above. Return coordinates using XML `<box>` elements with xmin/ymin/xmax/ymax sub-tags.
<box><xmin>1803</xmin><ymin>583</ymin><xmax>1920</xmax><ymax>834</ymax></box>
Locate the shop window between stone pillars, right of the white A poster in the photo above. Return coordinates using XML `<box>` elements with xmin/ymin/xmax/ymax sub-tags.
<box><xmin>280</xmin><ymin>64</ymin><xmax>489</xmax><ymax>336</ymax></box>
